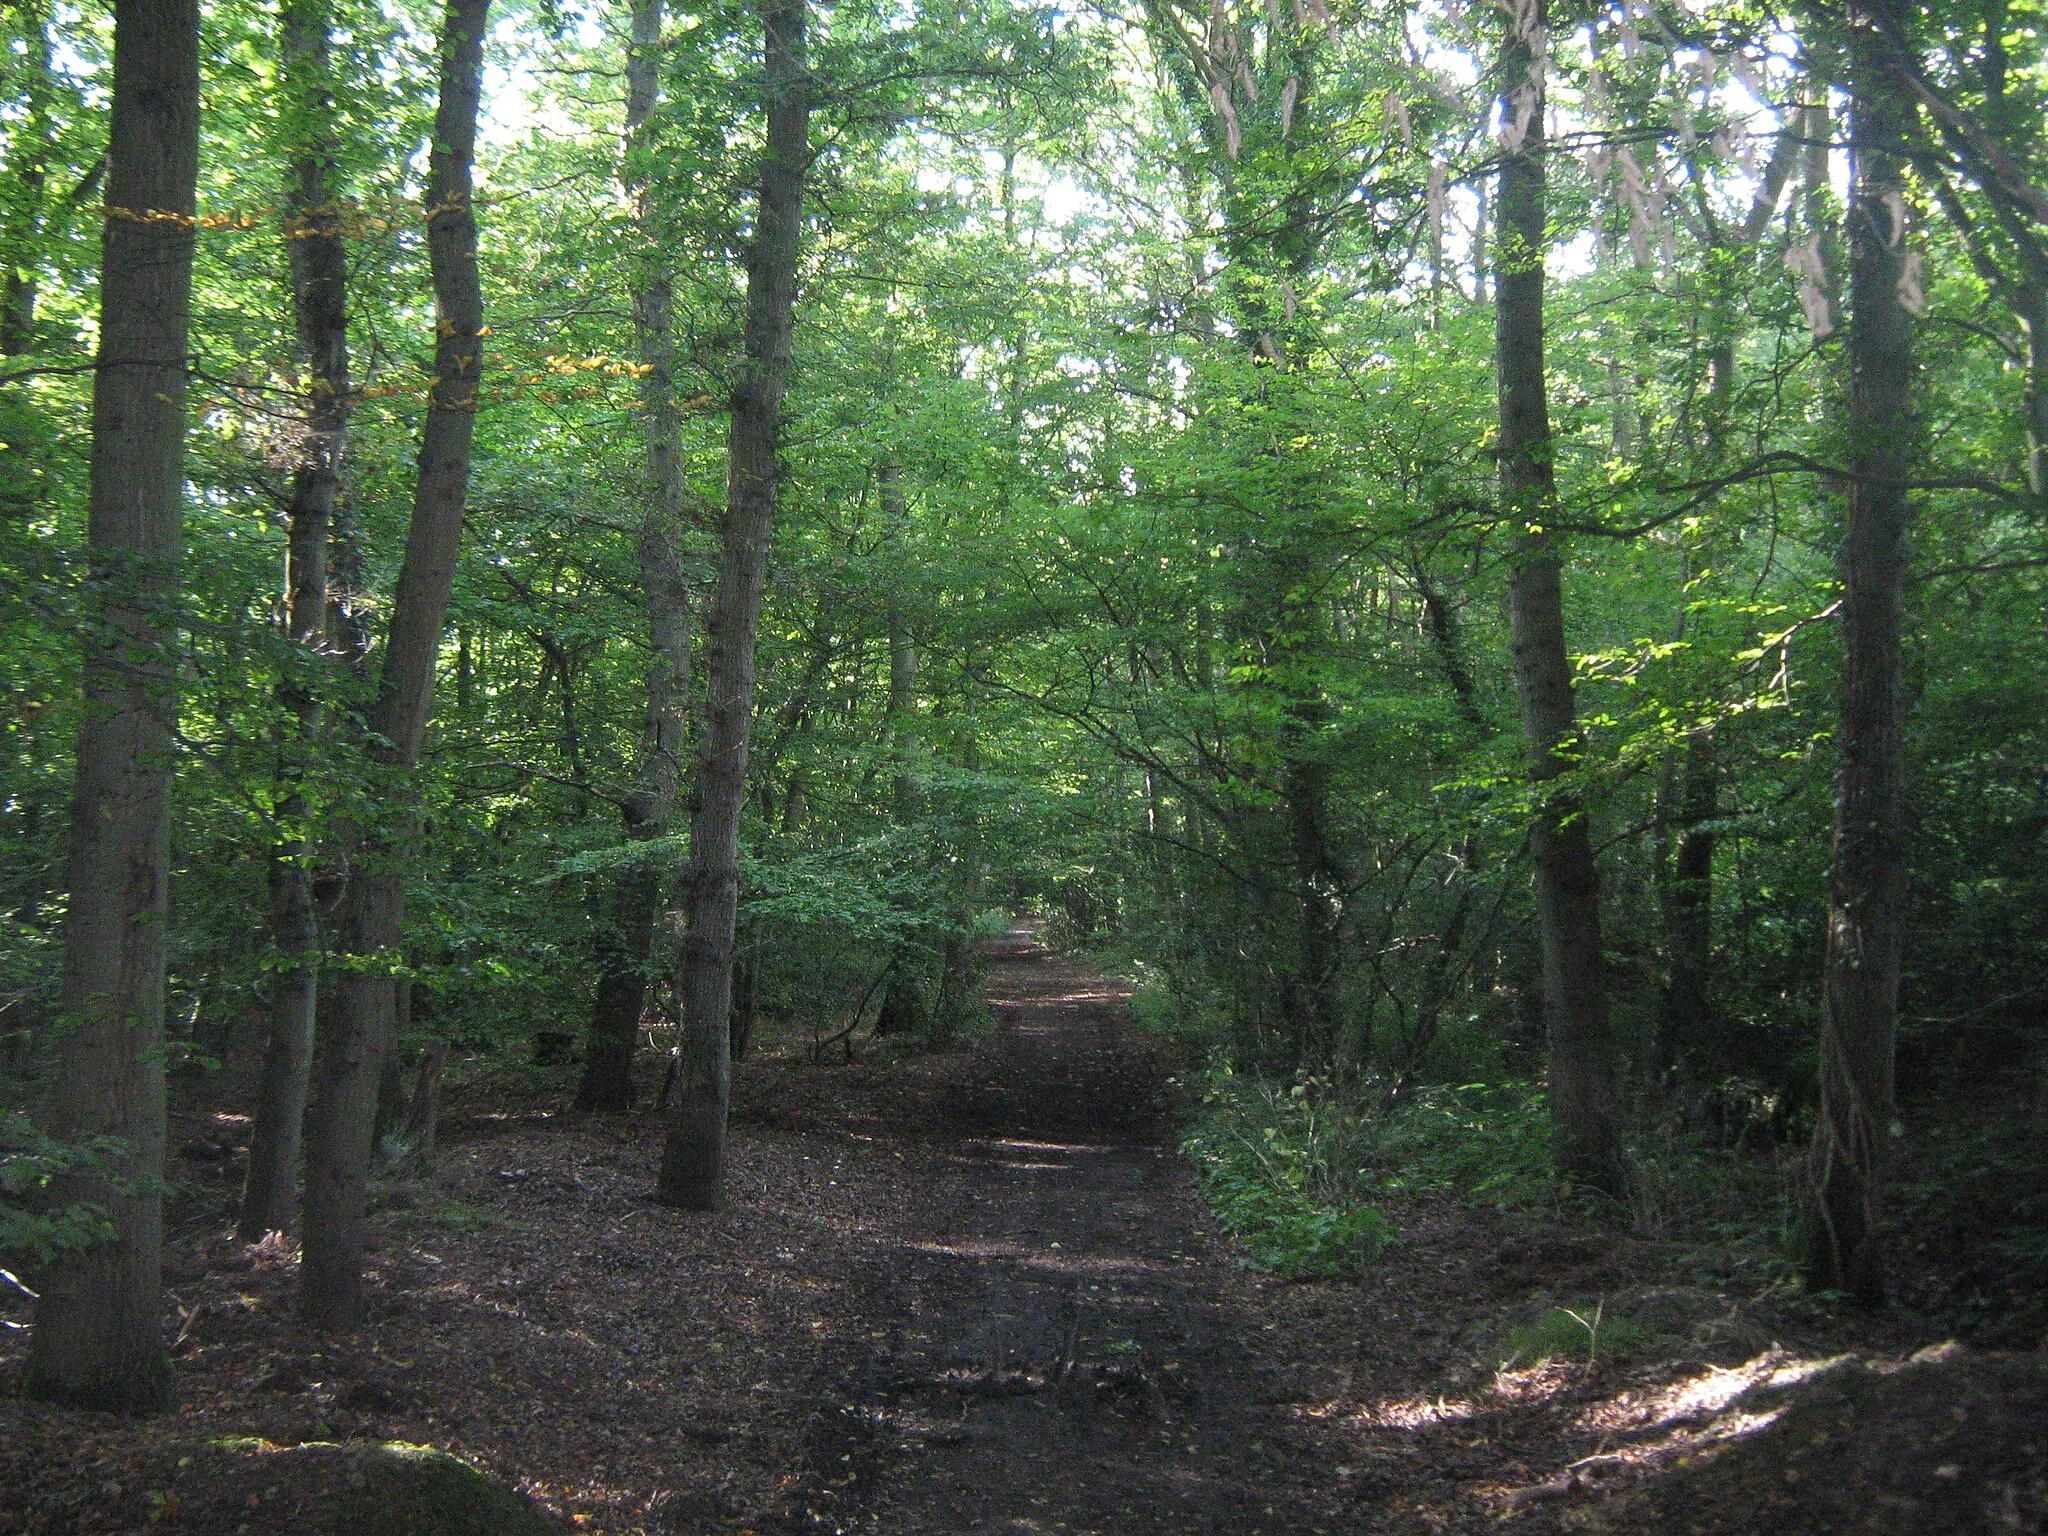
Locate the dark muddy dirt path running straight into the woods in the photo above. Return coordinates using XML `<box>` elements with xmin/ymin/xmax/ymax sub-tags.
<box><xmin>770</xmin><ymin>926</ymin><xmax>1331</xmax><ymax>1536</ymax></box>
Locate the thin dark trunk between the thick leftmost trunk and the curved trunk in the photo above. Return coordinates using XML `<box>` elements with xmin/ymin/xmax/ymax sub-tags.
<box><xmin>238</xmin><ymin>0</ymin><xmax>348</xmax><ymax>1239</ymax></box>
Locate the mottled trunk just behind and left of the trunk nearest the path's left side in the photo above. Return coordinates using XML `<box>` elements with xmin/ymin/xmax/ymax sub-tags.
<box><xmin>575</xmin><ymin>0</ymin><xmax>690</xmax><ymax>1112</ymax></box>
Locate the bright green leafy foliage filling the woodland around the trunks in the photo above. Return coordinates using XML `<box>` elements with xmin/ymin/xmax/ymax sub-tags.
<box><xmin>0</xmin><ymin>0</ymin><xmax>2048</xmax><ymax>1351</ymax></box>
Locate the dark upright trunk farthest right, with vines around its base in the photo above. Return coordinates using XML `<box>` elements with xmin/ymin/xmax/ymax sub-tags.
<box><xmin>1800</xmin><ymin>0</ymin><xmax>1915</xmax><ymax>1303</ymax></box>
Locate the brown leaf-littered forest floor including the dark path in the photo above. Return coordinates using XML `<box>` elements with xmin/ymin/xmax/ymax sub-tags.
<box><xmin>0</xmin><ymin>928</ymin><xmax>2042</xmax><ymax>1536</ymax></box>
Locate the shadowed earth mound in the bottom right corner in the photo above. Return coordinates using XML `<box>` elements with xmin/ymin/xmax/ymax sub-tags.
<box><xmin>1573</xmin><ymin>1343</ymin><xmax>2048</xmax><ymax>1536</ymax></box>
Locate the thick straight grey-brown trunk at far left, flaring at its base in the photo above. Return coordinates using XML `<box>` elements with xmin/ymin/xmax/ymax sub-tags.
<box><xmin>23</xmin><ymin>0</ymin><xmax>199</xmax><ymax>1411</ymax></box>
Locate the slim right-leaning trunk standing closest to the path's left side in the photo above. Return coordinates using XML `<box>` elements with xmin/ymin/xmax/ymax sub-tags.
<box><xmin>655</xmin><ymin>0</ymin><xmax>811</xmax><ymax>1210</ymax></box>
